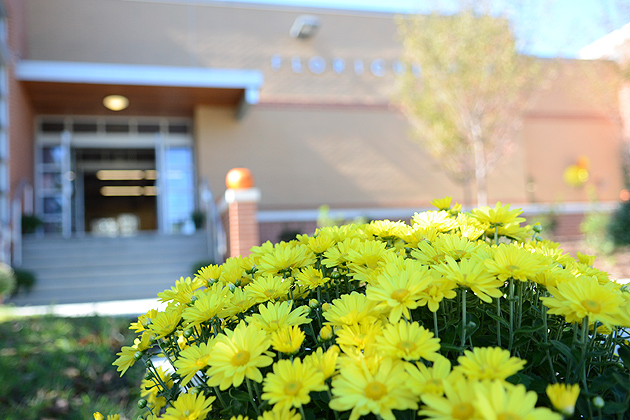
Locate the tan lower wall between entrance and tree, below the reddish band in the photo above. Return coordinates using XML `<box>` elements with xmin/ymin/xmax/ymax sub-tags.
<box><xmin>195</xmin><ymin>105</ymin><xmax>524</xmax><ymax>209</ymax></box>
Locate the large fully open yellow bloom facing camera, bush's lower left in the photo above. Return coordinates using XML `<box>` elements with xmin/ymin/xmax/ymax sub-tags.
<box><xmin>207</xmin><ymin>322</ymin><xmax>273</xmax><ymax>390</ymax></box>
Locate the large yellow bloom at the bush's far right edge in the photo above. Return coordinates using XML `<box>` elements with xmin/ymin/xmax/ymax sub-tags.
<box><xmin>541</xmin><ymin>276</ymin><xmax>623</xmax><ymax>326</ymax></box>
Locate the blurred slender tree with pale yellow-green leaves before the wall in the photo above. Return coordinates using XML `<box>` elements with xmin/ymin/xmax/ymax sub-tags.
<box><xmin>398</xmin><ymin>7</ymin><xmax>540</xmax><ymax>206</ymax></box>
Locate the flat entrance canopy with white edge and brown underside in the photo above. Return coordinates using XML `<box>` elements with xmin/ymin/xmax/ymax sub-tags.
<box><xmin>15</xmin><ymin>60</ymin><xmax>263</xmax><ymax>116</ymax></box>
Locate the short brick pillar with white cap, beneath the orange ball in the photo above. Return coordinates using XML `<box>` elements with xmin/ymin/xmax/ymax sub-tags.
<box><xmin>220</xmin><ymin>188</ymin><xmax>260</xmax><ymax>257</ymax></box>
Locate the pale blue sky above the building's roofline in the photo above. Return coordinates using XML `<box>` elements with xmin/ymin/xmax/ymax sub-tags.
<box><xmin>218</xmin><ymin>0</ymin><xmax>630</xmax><ymax>58</ymax></box>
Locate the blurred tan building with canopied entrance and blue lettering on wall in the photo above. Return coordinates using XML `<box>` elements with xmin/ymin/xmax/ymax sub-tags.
<box><xmin>0</xmin><ymin>0</ymin><xmax>624</xmax><ymax>270</ymax></box>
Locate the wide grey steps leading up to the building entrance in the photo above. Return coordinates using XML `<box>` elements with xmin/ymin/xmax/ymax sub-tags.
<box><xmin>7</xmin><ymin>232</ymin><xmax>208</xmax><ymax>306</ymax></box>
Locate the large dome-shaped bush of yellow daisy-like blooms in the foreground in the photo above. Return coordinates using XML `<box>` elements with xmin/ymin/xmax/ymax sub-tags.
<box><xmin>100</xmin><ymin>197</ymin><xmax>630</xmax><ymax>420</ymax></box>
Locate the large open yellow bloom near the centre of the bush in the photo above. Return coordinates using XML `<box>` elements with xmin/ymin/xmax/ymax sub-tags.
<box><xmin>365</xmin><ymin>260</ymin><xmax>431</xmax><ymax>322</ymax></box>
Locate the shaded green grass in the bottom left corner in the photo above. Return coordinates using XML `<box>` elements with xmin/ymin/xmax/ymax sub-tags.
<box><xmin>0</xmin><ymin>316</ymin><xmax>144</xmax><ymax>420</ymax></box>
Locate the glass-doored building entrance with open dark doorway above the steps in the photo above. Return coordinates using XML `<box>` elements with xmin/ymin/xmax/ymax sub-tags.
<box><xmin>35</xmin><ymin>117</ymin><xmax>195</xmax><ymax>237</ymax></box>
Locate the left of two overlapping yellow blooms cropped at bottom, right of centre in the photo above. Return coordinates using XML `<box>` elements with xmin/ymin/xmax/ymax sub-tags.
<box><xmin>418</xmin><ymin>380</ymin><xmax>478</xmax><ymax>420</ymax></box>
